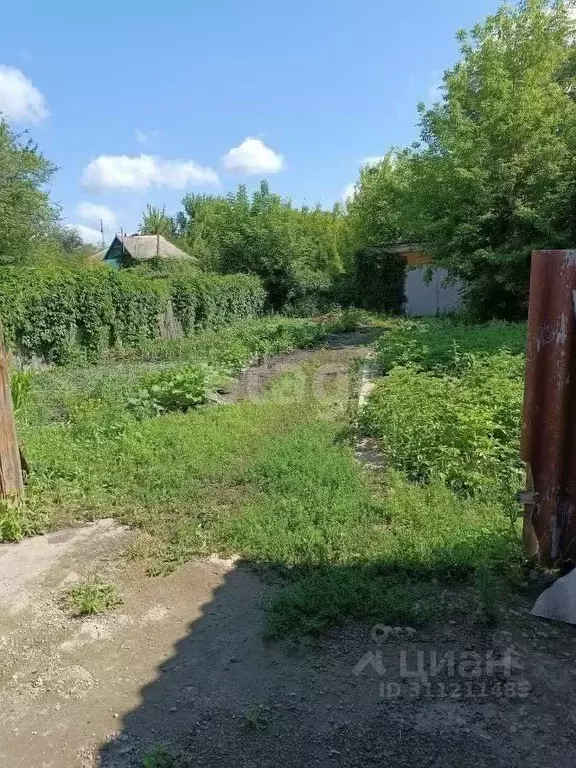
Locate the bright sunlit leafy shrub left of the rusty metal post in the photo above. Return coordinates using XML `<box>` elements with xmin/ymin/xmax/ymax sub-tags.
<box><xmin>361</xmin><ymin>352</ymin><xmax>523</xmax><ymax>493</ymax></box>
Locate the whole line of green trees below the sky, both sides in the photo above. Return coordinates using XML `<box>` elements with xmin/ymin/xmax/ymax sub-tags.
<box><xmin>0</xmin><ymin>0</ymin><xmax>576</xmax><ymax>319</ymax></box>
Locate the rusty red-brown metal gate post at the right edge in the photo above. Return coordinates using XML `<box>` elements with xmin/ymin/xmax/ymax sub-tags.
<box><xmin>522</xmin><ymin>251</ymin><xmax>576</xmax><ymax>566</ymax></box>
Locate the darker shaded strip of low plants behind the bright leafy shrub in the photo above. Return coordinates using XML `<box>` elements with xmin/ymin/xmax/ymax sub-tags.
<box><xmin>376</xmin><ymin>319</ymin><xmax>526</xmax><ymax>376</ymax></box>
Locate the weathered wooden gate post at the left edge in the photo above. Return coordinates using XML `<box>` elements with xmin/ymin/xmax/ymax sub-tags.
<box><xmin>0</xmin><ymin>321</ymin><xmax>24</xmax><ymax>498</ymax></box>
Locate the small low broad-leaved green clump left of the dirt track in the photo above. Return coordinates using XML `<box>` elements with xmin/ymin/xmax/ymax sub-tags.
<box><xmin>128</xmin><ymin>363</ymin><xmax>226</xmax><ymax>417</ymax></box>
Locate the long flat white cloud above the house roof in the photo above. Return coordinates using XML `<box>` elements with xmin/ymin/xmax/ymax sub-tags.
<box><xmin>81</xmin><ymin>155</ymin><xmax>218</xmax><ymax>192</ymax></box>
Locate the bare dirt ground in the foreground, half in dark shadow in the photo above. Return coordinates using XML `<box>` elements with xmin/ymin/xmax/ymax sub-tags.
<box><xmin>0</xmin><ymin>336</ymin><xmax>576</xmax><ymax>768</ymax></box>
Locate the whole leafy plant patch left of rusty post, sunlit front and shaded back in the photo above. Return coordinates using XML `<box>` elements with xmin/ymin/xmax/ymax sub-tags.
<box><xmin>362</xmin><ymin>320</ymin><xmax>526</xmax><ymax>504</ymax></box>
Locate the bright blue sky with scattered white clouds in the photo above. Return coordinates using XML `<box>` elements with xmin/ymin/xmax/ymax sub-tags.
<box><xmin>0</xmin><ymin>0</ymin><xmax>498</xmax><ymax>239</ymax></box>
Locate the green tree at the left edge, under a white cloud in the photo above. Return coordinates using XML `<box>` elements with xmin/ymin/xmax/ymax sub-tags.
<box><xmin>0</xmin><ymin>119</ymin><xmax>58</xmax><ymax>265</ymax></box>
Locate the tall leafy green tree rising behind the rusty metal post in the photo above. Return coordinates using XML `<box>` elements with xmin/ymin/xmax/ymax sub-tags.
<box><xmin>349</xmin><ymin>0</ymin><xmax>576</xmax><ymax>319</ymax></box>
